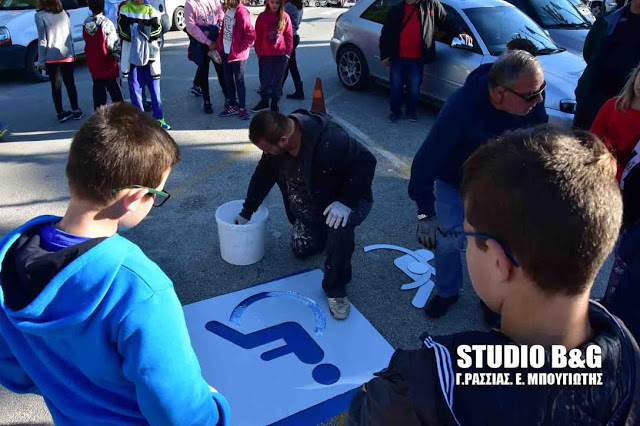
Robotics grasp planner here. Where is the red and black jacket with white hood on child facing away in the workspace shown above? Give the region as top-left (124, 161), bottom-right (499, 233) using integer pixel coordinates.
top-left (82, 14), bottom-right (120, 80)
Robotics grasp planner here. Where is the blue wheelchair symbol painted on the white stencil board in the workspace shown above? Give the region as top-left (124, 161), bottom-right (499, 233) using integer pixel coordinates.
top-left (205, 291), bottom-right (340, 385)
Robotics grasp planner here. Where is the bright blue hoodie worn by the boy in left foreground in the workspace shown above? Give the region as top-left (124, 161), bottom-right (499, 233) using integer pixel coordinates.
top-left (0, 216), bottom-right (229, 425)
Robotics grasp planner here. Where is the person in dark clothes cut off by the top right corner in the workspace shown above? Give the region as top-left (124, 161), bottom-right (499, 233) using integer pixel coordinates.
top-left (573, 0), bottom-right (640, 130)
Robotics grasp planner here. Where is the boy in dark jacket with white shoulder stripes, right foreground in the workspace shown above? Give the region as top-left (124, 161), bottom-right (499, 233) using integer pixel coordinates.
top-left (347, 126), bottom-right (640, 426)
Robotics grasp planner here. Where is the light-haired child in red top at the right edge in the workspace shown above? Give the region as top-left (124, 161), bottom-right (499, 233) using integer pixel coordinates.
top-left (591, 66), bottom-right (640, 181)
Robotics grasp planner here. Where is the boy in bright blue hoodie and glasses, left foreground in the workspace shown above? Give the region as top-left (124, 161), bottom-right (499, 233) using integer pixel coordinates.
top-left (0, 103), bottom-right (229, 425)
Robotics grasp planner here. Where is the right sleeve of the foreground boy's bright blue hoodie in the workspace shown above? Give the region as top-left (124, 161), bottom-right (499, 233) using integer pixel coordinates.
top-left (118, 287), bottom-right (230, 426)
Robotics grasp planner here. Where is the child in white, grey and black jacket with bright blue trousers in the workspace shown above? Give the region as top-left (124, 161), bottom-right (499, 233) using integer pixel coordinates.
top-left (118, 0), bottom-right (171, 130)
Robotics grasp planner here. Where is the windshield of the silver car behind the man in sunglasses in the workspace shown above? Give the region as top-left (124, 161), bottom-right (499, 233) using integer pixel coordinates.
top-left (464, 6), bottom-right (563, 56)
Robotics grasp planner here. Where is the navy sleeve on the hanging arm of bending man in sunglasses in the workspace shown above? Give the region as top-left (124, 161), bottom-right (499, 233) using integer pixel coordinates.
top-left (409, 100), bottom-right (464, 216)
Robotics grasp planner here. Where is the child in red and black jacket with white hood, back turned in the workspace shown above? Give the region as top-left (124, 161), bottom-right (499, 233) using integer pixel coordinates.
top-left (82, 0), bottom-right (123, 110)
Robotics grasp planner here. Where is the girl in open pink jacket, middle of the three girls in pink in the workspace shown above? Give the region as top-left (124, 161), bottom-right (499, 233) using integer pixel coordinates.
top-left (218, 0), bottom-right (256, 120)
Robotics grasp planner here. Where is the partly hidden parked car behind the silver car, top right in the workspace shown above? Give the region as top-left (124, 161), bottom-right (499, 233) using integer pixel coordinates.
top-left (506, 0), bottom-right (595, 55)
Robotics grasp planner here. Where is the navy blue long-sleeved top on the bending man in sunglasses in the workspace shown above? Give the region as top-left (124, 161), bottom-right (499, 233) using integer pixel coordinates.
top-left (409, 73), bottom-right (548, 216)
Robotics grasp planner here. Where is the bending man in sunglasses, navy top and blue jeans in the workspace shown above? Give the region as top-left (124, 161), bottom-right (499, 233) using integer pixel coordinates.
top-left (409, 50), bottom-right (546, 318)
